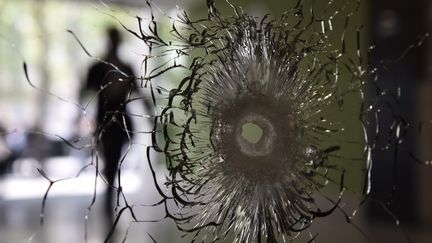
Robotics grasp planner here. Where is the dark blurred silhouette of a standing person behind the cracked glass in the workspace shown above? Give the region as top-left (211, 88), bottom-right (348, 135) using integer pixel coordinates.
top-left (81, 27), bottom-right (152, 233)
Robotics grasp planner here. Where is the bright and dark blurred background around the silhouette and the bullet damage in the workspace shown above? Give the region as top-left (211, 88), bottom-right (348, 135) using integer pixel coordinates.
top-left (0, 0), bottom-right (432, 243)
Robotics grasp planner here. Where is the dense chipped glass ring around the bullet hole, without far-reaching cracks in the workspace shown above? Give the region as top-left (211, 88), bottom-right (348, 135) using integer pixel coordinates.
top-left (143, 1), bottom-right (370, 242)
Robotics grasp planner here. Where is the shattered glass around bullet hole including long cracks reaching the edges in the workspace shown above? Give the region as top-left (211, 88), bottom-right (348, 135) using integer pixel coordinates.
top-left (1, 0), bottom-right (431, 242)
